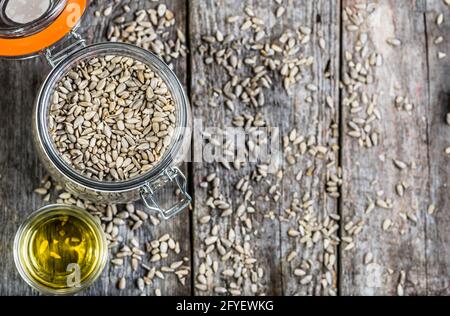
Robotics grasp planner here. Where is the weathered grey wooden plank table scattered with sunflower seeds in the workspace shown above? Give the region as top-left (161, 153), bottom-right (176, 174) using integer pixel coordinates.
top-left (0, 0), bottom-right (450, 295)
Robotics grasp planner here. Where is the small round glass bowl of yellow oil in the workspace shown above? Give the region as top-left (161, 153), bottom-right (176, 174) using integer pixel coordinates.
top-left (14, 205), bottom-right (108, 295)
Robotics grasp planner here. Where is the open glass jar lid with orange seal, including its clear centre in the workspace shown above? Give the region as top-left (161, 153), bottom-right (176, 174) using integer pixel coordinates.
top-left (0, 0), bottom-right (88, 58)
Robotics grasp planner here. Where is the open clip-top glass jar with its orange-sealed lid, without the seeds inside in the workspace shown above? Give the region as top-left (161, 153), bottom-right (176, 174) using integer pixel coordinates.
top-left (0, 0), bottom-right (192, 219)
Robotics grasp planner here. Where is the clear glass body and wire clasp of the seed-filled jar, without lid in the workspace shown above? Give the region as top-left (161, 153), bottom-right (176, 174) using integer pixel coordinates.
top-left (33, 43), bottom-right (192, 219)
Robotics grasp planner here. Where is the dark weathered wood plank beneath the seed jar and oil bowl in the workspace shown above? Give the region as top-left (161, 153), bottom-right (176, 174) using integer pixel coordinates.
top-left (0, 0), bottom-right (191, 295)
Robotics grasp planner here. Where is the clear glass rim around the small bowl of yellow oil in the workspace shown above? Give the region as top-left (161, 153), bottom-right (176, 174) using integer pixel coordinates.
top-left (13, 204), bottom-right (108, 295)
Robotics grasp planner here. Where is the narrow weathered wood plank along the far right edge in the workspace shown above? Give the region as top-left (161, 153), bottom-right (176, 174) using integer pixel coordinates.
top-left (426, 1), bottom-right (450, 295)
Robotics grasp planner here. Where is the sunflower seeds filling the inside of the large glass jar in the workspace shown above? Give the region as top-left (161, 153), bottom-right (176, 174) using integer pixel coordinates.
top-left (48, 55), bottom-right (176, 181)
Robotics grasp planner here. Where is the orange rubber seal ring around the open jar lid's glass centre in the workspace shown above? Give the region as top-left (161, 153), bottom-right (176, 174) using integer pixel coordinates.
top-left (0, 0), bottom-right (88, 57)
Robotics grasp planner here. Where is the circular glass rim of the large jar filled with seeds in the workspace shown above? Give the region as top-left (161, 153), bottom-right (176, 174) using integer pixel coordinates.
top-left (34, 42), bottom-right (190, 192)
